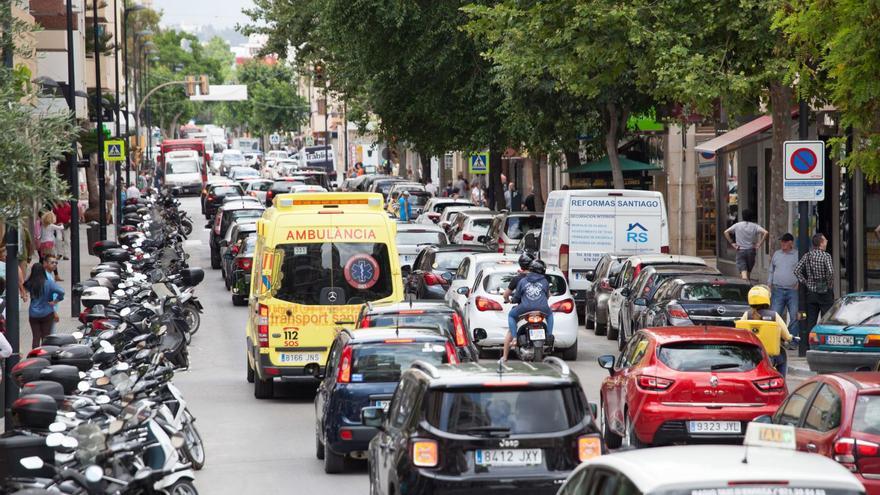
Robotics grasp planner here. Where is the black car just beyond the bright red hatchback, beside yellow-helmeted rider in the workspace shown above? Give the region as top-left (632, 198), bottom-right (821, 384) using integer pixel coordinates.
top-left (640, 275), bottom-right (752, 328)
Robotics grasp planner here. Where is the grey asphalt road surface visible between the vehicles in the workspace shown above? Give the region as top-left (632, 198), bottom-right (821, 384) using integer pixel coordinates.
top-left (175, 197), bottom-right (792, 495)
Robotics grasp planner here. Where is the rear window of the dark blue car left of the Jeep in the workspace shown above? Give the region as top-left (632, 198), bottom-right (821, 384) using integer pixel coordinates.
top-left (351, 339), bottom-right (446, 383)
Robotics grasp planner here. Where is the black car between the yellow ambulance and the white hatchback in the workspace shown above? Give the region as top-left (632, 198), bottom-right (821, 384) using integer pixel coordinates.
top-left (404, 244), bottom-right (489, 300)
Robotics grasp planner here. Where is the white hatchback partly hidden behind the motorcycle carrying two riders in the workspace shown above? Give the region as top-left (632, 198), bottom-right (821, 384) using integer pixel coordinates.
top-left (462, 263), bottom-right (578, 361)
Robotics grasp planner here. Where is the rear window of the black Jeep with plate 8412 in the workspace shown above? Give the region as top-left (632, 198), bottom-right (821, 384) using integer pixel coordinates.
top-left (429, 389), bottom-right (584, 436)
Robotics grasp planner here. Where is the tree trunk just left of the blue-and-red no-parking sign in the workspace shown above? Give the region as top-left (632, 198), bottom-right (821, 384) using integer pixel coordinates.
top-left (768, 81), bottom-right (793, 248)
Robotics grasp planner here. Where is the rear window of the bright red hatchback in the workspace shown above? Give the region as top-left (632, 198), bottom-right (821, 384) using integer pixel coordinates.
top-left (657, 342), bottom-right (764, 372)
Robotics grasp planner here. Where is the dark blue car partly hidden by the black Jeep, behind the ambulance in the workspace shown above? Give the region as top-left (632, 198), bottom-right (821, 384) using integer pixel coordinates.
top-left (315, 325), bottom-right (458, 474)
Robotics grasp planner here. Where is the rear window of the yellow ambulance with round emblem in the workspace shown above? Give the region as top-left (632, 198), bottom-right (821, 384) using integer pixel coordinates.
top-left (275, 242), bottom-right (394, 305)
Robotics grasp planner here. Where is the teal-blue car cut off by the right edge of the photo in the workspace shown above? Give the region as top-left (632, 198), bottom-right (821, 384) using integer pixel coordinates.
top-left (807, 292), bottom-right (880, 373)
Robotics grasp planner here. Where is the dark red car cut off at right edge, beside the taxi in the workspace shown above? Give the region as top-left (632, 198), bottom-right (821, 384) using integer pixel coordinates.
top-left (773, 372), bottom-right (880, 495)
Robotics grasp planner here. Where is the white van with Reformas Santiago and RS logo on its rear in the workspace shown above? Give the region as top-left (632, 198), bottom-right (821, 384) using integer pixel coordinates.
top-left (540, 189), bottom-right (669, 292)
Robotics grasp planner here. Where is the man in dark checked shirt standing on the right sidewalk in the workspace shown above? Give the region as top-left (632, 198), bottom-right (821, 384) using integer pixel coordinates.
top-left (794, 233), bottom-right (834, 342)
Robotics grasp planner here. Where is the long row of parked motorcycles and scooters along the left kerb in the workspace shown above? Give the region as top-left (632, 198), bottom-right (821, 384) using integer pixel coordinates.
top-left (0, 195), bottom-right (205, 495)
